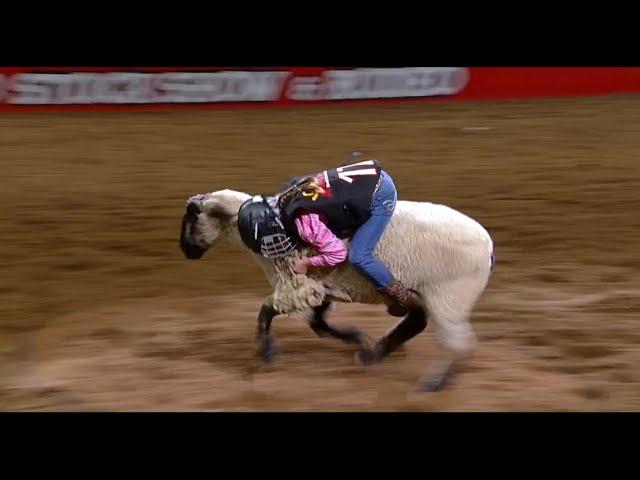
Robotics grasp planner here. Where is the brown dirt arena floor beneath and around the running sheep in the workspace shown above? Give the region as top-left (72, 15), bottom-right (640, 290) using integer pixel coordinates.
top-left (0, 96), bottom-right (640, 411)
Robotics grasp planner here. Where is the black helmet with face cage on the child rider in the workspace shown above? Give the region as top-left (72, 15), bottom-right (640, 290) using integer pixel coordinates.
top-left (238, 195), bottom-right (298, 258)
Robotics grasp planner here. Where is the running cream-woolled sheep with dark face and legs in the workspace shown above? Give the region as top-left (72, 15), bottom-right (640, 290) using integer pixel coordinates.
top-left (180, 189), bottom-right (494, 391)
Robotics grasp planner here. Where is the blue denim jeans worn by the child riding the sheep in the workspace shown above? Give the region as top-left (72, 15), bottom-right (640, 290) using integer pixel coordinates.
top-left (349, 171), bottom-right (398, 288)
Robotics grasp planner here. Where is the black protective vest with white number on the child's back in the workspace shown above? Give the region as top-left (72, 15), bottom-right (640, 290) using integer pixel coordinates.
top-left (280, 160), bottom-right (382, 238)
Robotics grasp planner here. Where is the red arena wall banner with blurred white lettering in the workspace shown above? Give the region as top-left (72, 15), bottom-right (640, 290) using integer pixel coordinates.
top-left (0, 67), bottom-right (640, 111)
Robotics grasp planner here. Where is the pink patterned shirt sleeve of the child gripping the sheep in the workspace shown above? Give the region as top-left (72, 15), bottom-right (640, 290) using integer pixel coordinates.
top-left (294, 212), bottom-right (347, 267)
